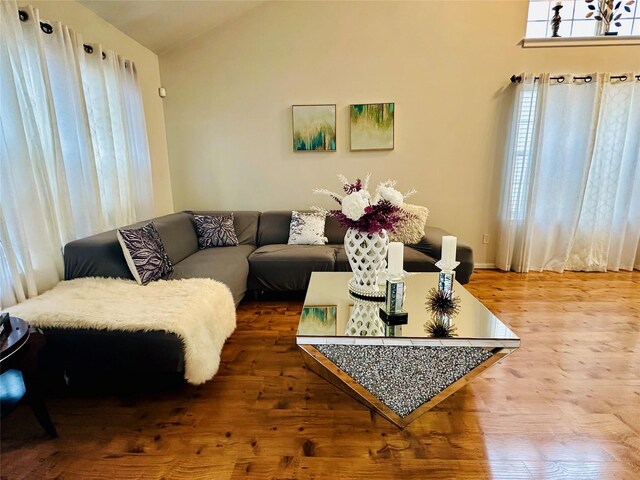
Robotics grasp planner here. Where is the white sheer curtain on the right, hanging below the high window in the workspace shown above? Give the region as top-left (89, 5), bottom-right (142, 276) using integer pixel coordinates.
top-left (496, 73), bottom-right (640, 272)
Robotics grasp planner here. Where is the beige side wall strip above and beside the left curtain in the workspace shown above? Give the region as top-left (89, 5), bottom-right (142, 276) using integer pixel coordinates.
top-left (30, 1), bottom-right (173, 215)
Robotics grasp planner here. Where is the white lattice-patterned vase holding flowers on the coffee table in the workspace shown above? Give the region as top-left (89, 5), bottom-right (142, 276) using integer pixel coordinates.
top-left (344, 228), bottom-right (389, 295)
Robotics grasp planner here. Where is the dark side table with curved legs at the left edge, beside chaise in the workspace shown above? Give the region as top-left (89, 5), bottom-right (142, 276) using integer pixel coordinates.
top-left (0, 317), bottom-right (58, 438)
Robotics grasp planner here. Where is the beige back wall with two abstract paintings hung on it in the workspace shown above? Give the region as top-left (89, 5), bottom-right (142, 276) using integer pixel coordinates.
top-left (160, 1), bottom-right (640, 263)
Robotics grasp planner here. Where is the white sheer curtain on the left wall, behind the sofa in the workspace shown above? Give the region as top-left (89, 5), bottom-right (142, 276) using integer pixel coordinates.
top-left (0, 1), bottom-right (153, 308)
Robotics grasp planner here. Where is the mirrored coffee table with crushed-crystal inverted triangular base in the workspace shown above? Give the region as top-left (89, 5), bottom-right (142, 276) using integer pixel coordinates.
top-left (296, 272), bottom-right (520, 427)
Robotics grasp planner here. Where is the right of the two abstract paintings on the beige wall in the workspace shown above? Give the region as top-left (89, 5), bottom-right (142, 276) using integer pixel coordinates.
top-left (350, 103), bottom-right (395, 151)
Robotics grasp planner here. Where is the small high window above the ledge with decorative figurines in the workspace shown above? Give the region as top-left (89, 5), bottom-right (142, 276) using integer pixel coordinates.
top-left (525, 0), bottom-right (640, 38)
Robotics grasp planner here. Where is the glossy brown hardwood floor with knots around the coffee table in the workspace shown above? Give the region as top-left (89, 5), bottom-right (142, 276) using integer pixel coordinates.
top-left (1, 270), bottom-right (640, 480)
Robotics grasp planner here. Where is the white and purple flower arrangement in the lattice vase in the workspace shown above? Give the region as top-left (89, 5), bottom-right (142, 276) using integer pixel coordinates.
top-left (312, 174), bottom-right (416, 234)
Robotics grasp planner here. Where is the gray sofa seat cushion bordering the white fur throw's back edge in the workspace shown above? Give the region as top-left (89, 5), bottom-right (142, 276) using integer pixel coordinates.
top-left (166, 245), bottom-right (256, 306)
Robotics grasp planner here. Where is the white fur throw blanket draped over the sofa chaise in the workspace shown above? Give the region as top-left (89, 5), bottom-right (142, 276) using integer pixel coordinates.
top-left (9, 278), bottom-right (236, 384)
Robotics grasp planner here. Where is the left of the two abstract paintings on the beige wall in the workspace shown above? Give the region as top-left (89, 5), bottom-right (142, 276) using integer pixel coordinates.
top-left (291, 105), bottom-right (336, 152)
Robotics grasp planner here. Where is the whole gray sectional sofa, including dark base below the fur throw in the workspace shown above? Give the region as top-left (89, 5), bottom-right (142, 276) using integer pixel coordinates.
top-left (44, 211), bottom-right (473, 382)
